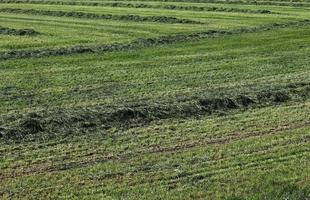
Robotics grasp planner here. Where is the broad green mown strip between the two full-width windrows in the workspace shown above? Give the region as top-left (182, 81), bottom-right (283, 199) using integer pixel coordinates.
top-left (0, 24), bottom-right (309, 113)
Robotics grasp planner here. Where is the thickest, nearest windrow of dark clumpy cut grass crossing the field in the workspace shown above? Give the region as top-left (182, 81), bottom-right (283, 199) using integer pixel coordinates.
top-left (0, 83), bottom-right (310, 142)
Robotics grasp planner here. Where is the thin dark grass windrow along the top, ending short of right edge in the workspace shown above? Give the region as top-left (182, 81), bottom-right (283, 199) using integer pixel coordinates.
top-left (1, 0), bottom-right (276, 14)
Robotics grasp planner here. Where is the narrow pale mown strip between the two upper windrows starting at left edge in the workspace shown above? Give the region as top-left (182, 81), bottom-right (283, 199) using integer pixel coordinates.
top-left (0, 3), bottom-right (302, 23)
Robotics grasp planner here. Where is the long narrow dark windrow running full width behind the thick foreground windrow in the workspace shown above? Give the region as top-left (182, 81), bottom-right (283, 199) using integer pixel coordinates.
top-left (0, 19), bottom-right (310, 60)
